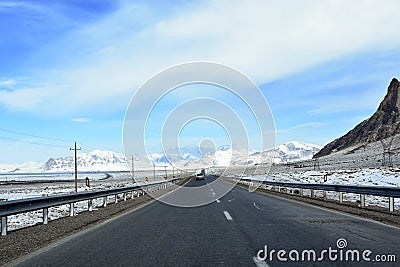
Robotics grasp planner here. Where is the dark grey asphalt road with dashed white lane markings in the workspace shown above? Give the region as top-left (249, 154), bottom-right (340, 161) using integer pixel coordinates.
top-left (14, 176), bottom-right (400, 266)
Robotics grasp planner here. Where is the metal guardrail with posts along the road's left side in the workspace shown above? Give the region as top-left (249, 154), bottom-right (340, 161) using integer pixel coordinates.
top-left (0, 178), bottom-right (180, 236)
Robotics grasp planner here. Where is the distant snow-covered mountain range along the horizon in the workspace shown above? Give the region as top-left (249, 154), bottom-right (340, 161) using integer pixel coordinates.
top-left (0, 142), bottom-right (321, 173)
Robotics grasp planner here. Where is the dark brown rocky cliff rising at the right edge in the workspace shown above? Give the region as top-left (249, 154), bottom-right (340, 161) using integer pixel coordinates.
top-left (314, 79), bottom-right (400, 158)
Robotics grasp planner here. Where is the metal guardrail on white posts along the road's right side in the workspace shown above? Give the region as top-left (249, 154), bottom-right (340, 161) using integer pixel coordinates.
top-left (235, 179), bottom-right (400, 215)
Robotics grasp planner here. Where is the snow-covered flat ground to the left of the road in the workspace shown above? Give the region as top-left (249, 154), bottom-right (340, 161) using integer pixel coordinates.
top-left (0, 171), bottom-right (173, 230)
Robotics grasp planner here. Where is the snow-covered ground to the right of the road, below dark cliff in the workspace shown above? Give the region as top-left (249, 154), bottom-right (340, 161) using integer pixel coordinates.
top-left (230, 168), bottom-right (400, 213)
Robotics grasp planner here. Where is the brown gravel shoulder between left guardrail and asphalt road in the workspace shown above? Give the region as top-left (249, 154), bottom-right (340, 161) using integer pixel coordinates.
top-left (0, 178), bottom-right (190, 266)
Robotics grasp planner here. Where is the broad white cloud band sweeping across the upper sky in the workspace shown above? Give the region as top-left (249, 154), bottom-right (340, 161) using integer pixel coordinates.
top-left (0, 1), bottom-right (400, 116)
